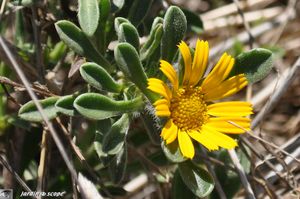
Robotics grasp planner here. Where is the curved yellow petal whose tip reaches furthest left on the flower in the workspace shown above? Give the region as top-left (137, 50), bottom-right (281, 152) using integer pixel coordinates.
top-left (147, 78), bottom-right (172, 101)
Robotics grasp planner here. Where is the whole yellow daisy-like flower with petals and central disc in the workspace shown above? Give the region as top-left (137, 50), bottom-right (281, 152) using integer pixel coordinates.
top-left (148, 40), bottom-right (252, 158)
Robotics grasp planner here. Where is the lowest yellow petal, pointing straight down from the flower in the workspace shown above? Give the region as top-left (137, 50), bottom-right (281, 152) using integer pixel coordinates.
top-left (178, 129), bottom-right (195, 159)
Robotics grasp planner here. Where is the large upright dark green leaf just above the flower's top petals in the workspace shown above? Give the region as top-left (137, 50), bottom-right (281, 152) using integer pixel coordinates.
top-left (161, 6), bottom-right (187, 62)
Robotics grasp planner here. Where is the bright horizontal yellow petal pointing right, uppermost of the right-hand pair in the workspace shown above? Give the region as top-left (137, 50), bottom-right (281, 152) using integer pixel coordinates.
top-left (207, 101), bottom-right (253, 117)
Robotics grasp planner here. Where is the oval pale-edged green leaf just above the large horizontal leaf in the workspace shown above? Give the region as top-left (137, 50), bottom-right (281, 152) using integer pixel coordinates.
top-left (80, 62), bottom-right (122, 93)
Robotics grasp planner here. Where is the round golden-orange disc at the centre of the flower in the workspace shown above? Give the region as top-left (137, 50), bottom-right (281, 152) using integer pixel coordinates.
top-left (170, 87), bottom-right (208, 131)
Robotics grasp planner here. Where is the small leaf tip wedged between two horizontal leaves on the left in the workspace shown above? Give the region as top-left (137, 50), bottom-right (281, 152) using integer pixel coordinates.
top-left (55, 95), bottom-right (76, 117)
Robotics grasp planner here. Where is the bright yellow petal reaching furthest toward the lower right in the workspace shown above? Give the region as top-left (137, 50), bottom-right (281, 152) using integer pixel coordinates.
top-left (202, 125), bottom-right (237, 149)
